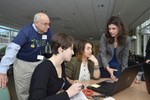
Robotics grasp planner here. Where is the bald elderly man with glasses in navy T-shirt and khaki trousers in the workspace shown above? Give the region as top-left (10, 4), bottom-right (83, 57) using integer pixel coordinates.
top-left (0, 12), bottom-right (52, 100)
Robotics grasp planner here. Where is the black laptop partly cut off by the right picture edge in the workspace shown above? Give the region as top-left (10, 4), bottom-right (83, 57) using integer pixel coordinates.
top-left (143, 63), bottom-right (150, 94)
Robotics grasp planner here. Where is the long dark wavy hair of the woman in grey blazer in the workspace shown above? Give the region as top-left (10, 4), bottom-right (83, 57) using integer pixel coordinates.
top-left (105, 16), bottom-right (128, 45)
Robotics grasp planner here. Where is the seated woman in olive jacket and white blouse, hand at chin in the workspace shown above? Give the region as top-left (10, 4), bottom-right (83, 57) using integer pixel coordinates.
top-left (66, 39), bottom-right (100, 83)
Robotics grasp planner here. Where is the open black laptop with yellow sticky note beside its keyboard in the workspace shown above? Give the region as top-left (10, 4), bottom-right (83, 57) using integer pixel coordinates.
top-left (87, 64), bottom-right (142, 96)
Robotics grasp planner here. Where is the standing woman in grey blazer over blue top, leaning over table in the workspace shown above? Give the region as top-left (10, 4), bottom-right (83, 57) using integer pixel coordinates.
top-left (100, 16), bottom-right (130, 80)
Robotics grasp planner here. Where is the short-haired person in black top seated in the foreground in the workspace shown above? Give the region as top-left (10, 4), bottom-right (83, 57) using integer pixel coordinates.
top-left (28, 33), bottom-right (82, 100)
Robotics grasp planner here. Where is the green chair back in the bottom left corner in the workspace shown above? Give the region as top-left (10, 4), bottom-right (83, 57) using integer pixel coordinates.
top-left (0, 87), bottom-right (11, 100)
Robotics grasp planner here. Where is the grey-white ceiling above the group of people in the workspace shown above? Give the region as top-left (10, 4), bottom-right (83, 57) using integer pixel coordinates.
top-left (0, 0), bottom-right (150, 40)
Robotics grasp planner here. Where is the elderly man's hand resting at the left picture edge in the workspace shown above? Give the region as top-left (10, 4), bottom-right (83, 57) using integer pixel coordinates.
top-left (0, 73), bottom-right (8, 89)
